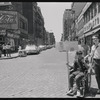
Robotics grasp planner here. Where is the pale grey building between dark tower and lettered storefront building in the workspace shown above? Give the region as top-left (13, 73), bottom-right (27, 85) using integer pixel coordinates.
top-left (71, 2), bottom-right (86, 40)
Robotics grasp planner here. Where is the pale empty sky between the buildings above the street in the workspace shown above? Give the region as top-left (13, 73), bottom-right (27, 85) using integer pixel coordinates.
top-left (37, 2), bottom-right (72, 42)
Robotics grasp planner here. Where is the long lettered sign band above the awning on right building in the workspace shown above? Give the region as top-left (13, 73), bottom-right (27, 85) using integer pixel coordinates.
top-left (84, 14), bottom-right (100, 33)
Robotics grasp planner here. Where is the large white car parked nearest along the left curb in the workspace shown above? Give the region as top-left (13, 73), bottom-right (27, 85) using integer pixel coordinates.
top-left (25, 45), bottom-right (40, 54)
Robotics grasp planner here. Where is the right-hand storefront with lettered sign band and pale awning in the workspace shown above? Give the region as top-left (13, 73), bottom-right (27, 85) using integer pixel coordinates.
top-left (84, 13), bottom-right (100, 46)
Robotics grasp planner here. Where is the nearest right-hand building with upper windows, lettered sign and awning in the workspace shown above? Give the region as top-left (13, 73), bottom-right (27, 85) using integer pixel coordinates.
top-left (77, 2), bottom-right (100, 46)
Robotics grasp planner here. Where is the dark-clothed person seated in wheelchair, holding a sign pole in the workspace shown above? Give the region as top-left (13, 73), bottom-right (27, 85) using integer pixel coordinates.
top-left (67, 51), bottom-right (87, 96)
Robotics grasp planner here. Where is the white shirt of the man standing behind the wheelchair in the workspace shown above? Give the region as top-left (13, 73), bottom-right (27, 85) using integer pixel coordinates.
top-left (91, 43), bottom-right (100, 59)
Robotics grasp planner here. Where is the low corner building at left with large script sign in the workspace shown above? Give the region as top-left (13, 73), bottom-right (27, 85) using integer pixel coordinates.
top-left (0, 10), bottom-right (28, 50)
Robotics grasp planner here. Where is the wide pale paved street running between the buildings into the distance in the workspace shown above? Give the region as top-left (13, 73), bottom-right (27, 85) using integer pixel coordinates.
top-left (0, 48), bottom-right (99, 98)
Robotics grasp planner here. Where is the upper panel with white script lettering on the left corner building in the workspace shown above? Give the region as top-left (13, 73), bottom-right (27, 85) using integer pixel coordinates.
top-left (0, 13), bottom-right (16, 24)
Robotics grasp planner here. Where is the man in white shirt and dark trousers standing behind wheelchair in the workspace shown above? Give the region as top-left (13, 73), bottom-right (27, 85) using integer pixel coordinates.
top-left (85, 35), bottom-right (100, 94)
